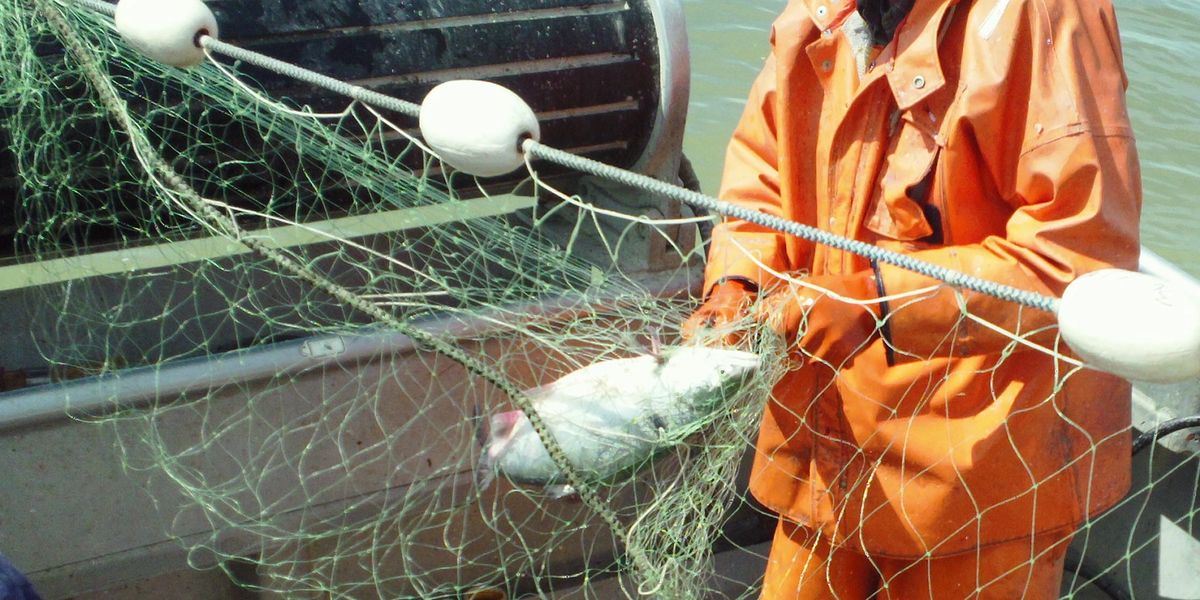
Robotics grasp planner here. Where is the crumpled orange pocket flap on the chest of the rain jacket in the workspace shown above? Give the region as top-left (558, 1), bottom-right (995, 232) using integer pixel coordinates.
top-left (864, 115), bottom-right (943, 244)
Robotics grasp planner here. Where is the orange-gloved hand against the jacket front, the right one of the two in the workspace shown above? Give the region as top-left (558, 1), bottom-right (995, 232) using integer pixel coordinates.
top-left (755, 272), bottom-right (880, 367)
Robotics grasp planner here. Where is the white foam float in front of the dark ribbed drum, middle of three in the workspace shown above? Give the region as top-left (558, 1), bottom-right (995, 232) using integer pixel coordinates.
top-left (420, 80), bottom-right (541, 178)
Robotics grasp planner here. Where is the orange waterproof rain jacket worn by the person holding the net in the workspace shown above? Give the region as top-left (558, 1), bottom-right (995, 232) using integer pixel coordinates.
top-left (706, 0), bottom-right (1141, 558)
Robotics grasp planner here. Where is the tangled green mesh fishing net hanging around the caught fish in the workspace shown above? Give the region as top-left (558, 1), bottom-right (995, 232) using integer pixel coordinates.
top-left (0, 0), bottom-right (1196, 598)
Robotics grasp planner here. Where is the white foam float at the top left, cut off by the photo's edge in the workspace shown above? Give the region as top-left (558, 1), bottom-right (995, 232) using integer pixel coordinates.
top-left (115, 0), bottom-right (217, 67)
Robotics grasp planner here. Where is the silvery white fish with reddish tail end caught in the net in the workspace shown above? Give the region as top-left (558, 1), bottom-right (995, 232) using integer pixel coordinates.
top-left (478, 347), bottom-right (760, 497)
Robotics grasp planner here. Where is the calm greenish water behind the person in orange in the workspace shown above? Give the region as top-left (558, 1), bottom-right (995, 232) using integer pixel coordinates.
top-left (684, 0), bottom-right (1200, 276)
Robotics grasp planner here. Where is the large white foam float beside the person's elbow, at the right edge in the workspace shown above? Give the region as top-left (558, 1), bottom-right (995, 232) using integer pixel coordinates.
top-left (1058, 269), bottom-right (1200, 383)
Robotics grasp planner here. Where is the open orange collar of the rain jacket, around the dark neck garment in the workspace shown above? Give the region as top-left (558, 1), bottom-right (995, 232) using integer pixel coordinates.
top-left (800, 0), bottom-right (959, 110)
